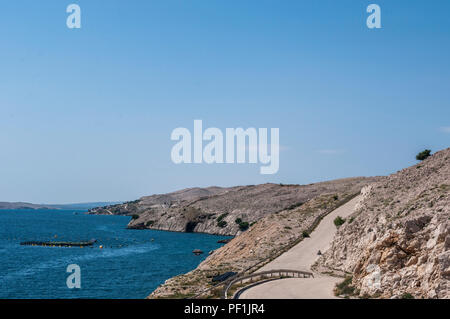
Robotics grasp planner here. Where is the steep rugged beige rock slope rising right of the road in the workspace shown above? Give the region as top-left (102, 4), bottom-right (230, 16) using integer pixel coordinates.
top-left (316, 149), bottom-right (450, 298)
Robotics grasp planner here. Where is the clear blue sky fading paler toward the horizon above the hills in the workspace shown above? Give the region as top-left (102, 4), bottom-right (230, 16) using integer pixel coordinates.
top-left (0, 0), bottom-right (450, 203)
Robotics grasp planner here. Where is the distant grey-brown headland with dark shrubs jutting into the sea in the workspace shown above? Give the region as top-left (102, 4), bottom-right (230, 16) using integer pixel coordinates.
top-left (89, 178), bottom-right (373, 235)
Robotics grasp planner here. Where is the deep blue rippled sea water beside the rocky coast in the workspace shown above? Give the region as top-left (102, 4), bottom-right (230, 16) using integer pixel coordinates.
top-left (0, 210), bottom-right (227, 299)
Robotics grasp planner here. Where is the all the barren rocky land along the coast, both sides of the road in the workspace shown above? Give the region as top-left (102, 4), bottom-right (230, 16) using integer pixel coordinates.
top-left (90, 149), bottom-right (450, 298)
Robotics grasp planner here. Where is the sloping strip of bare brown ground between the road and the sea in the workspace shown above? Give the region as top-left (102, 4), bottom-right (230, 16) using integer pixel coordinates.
top-left (149, 178), bottom-right (377, 298)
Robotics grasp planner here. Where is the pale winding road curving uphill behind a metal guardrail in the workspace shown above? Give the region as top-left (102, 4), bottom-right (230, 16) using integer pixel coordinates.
top-left (240, 196), bottom-right (361, 299)
